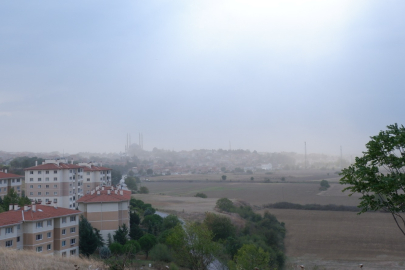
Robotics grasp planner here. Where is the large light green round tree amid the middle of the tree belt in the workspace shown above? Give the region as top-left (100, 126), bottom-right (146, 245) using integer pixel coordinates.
top-left (166, 223), bottom-right (219, 270)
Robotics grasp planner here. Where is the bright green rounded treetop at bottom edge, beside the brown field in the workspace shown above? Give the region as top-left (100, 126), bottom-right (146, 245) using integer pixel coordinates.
top-left (229, 244), bottom-right (270, 270)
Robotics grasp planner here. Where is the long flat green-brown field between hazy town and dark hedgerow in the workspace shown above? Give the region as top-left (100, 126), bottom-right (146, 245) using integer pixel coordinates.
top-left (142, 181), bottom-right (358, 206)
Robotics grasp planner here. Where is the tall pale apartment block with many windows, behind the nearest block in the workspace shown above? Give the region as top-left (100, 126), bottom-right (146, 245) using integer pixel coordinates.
top-left (25, 159), bottom-right (83, 209)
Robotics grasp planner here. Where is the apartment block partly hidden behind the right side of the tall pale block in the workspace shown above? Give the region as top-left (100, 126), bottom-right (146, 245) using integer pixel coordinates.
top-left (78, 163), bottom-right (111, 194)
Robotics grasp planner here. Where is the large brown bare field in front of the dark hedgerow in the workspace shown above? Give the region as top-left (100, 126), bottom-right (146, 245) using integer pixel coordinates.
top-left (258, 209), bottom-right (405, 269)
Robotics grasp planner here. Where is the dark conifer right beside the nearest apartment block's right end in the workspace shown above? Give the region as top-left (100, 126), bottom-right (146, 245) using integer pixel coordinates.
top-left (79, 216), bottom-right (99, 257)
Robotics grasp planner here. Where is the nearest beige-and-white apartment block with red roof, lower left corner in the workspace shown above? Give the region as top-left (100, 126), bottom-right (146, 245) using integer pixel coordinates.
top-left (0, 204), bottom-right (81, 257)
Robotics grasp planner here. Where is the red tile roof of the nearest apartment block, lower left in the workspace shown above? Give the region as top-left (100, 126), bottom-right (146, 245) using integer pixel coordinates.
top-left (0, 204), bottom-right (82, 227)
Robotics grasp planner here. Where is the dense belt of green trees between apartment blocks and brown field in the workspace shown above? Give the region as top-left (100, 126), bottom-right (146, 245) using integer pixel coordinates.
top-left (79, 198), bottom-right (285, 270)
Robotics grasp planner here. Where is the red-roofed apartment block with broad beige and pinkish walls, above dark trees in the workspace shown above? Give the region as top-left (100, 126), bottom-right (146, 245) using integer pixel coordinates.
top-left (77, 186), bottom-right (131, 240)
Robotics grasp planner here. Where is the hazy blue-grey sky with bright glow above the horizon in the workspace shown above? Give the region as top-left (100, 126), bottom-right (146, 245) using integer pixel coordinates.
top-left (0, 0), bottom-right (405, 154)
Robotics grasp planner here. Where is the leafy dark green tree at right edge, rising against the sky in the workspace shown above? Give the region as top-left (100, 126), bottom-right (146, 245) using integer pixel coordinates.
top-left (340, 124), bottom-right (405, 235)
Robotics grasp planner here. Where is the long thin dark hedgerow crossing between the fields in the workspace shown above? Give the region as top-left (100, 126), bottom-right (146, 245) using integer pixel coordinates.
top-left (263, 202), bottom-right (360, 212)
